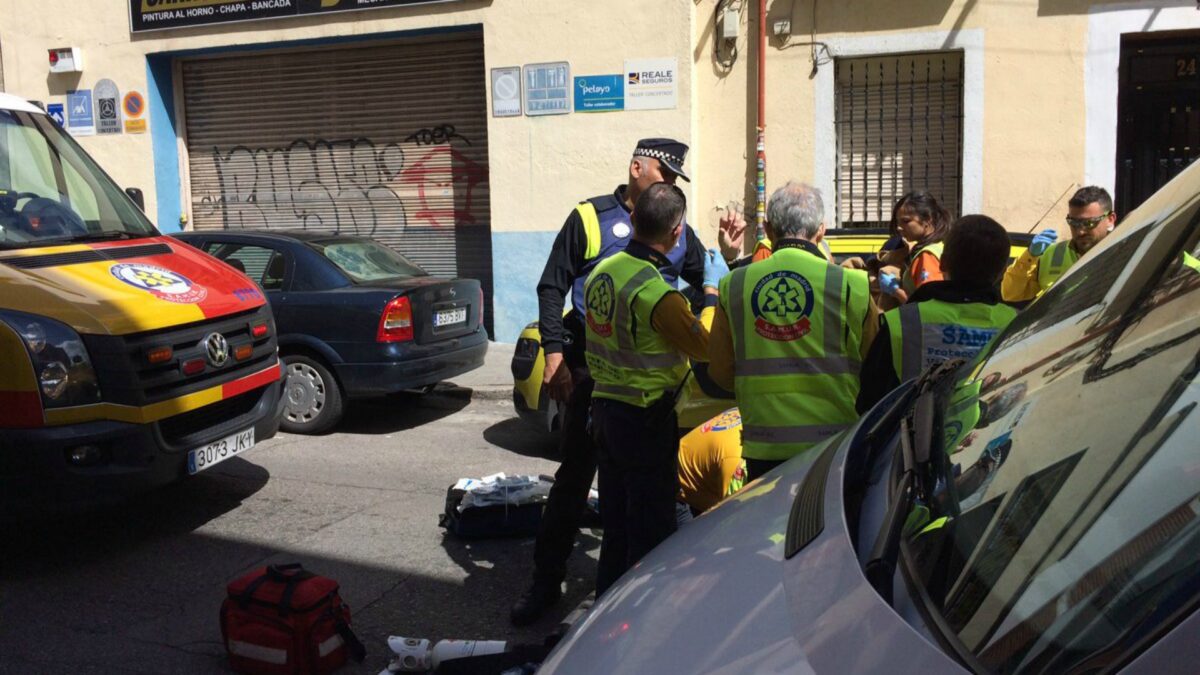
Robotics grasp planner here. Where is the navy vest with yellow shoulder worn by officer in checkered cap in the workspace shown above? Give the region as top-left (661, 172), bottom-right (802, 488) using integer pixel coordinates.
top-left (571, 193), bottom-right (689, 315)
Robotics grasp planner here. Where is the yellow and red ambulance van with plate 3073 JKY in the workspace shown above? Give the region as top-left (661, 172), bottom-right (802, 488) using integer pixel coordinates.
top-left (0, 94), bottom-right (282, 502)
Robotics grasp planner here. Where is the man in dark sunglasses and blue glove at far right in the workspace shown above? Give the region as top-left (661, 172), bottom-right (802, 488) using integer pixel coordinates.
top-left (1001, 185), bottom-right (1117, 303)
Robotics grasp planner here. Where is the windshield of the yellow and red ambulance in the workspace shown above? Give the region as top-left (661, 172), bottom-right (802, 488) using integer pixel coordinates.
top-left (0, 109), bottom-right (158, 250)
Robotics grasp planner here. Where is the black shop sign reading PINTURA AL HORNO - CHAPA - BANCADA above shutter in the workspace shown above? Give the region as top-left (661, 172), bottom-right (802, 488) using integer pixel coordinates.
top-left (130, 0), bottom-right (460, 32)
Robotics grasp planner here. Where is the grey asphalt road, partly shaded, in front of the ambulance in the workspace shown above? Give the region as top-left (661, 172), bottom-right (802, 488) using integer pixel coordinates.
top-left (0, 386), bottom-right (600, 674)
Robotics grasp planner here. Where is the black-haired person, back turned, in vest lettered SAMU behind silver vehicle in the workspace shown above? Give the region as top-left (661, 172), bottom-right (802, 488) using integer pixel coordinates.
top-left (856, 215), bottom-right (1016, 413)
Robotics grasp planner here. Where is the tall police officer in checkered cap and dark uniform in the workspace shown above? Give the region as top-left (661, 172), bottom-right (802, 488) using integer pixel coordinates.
top-left (510, 138), bottom-right (706, 626)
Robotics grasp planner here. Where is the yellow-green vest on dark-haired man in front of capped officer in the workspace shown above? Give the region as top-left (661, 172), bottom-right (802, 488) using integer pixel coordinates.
top-left (583, 251), bottom-right (688, 407)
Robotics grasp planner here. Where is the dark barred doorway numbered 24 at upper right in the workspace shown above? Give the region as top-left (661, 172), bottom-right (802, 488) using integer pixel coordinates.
top-left (1113, 30), bottom-right (1200, 215)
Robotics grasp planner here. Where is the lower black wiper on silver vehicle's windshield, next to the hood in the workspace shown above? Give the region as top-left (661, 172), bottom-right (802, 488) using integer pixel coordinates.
top-left (863, 360), bottom-right (962, 604)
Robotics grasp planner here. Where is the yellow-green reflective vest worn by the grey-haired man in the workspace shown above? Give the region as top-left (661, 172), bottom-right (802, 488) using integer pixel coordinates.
top-left (720, 247), bottom-right (870, 460)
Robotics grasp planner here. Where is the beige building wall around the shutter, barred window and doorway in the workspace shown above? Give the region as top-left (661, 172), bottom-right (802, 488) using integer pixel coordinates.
top-left (0, 0), bottom-right (1200, 241)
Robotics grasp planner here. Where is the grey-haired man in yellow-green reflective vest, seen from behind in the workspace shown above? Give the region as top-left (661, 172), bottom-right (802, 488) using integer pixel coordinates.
top-left (708, 183), bottom-right (877, 480)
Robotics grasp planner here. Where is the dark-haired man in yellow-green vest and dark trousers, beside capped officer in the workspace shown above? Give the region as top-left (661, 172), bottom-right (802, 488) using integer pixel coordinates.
top-left (583, 183), bottom-right (728, 597)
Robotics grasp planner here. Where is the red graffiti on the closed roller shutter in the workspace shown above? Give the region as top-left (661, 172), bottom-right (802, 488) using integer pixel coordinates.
top-left (401, 145), bottom-right (487, 227)
